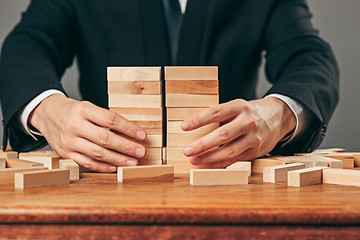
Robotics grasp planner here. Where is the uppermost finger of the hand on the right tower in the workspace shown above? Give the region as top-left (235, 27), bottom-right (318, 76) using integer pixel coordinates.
top-left (181, 99), bottom-right (245, 131)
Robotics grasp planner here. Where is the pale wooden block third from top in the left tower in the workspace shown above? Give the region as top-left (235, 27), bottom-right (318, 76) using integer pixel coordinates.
top-left (109, 94), bottom-right (162, 108)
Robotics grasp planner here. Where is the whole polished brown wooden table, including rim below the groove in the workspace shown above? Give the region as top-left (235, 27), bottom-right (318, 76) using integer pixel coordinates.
top-left (0, 173), bottom-right (360, 239)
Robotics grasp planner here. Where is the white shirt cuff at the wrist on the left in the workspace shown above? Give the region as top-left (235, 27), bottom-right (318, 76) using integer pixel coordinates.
top-left (18, 89), bottom-right (65, 140)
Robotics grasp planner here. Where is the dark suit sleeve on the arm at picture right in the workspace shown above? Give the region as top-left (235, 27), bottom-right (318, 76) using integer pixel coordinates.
top-left (265, 0), bottom-right (339, 155)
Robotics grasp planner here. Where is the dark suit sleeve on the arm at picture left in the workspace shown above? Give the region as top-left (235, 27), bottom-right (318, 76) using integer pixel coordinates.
top-left (0, 0), bottom-right (76, 151)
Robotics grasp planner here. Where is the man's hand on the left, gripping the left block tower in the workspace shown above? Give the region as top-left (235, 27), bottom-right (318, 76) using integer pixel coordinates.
top-left (29, 94), bottom-right (146, 172)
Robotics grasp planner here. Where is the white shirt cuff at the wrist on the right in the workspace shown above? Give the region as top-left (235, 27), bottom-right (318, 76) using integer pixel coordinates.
top-left (266, 94), bottom-right (312, 145)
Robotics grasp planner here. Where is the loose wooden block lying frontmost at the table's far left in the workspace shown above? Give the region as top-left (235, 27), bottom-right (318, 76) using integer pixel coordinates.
top-left (15, 169), bottom-right (70, 189)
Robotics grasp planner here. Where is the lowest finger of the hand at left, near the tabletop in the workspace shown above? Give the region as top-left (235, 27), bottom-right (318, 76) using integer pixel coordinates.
top-left (70, 152), bottom-right (116, 173)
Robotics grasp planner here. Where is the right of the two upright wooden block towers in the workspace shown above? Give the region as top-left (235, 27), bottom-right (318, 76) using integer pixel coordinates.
top-left (165, 67), bottom-right (219, 173)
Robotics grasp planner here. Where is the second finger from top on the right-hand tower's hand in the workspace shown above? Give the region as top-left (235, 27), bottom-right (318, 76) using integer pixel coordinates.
top-left (184, 115), bottom-right (254, 157)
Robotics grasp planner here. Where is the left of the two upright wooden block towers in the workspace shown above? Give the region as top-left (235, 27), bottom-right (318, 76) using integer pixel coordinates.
top-left (107, 67), bottom-right (163, 165)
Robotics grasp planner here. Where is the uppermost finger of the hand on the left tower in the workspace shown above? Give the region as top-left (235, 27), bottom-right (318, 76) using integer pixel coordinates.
top-left (80, 102), bottom-right (146, 141)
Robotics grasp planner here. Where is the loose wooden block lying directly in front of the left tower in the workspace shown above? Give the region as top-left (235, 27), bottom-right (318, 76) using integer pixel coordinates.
top-left (118, 165), bottom-right (174, 183)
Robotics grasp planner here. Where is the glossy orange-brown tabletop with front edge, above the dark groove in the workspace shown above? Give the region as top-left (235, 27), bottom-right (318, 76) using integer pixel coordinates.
top-left (0, 173), bottom-right (360, 226)
